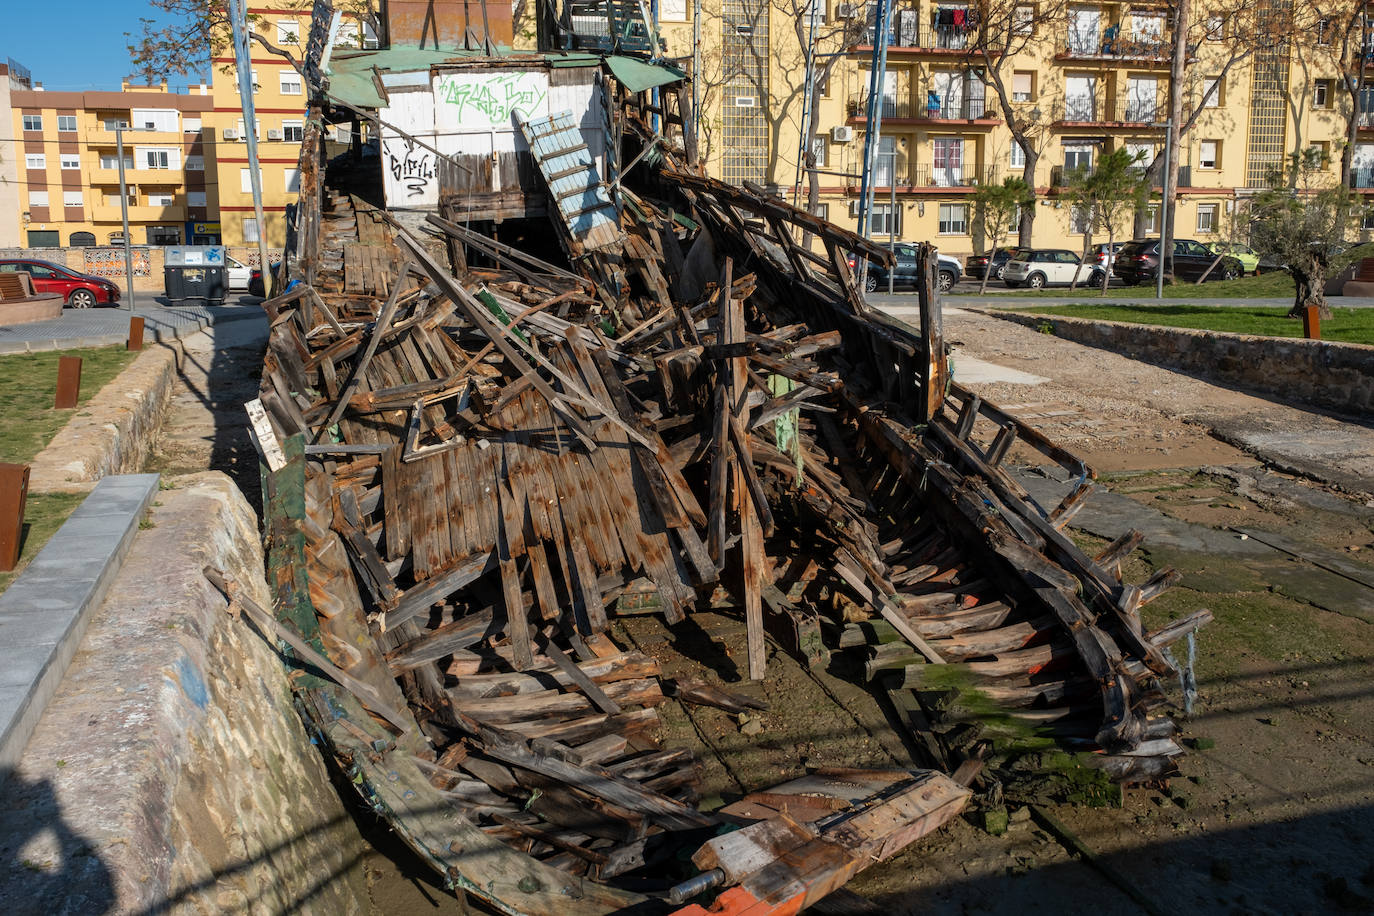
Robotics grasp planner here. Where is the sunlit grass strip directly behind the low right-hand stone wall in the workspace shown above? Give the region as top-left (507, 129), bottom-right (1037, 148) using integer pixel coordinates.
top-left (1015, 305), bottom-right (1374, 345)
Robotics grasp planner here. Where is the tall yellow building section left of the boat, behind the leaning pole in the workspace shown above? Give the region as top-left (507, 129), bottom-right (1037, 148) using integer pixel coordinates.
top-left (206, 0), bottom-right (376, 249)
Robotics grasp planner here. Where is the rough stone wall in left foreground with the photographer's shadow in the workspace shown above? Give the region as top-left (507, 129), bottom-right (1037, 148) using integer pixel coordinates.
top-left (0, 472), bottom-right (368, 916)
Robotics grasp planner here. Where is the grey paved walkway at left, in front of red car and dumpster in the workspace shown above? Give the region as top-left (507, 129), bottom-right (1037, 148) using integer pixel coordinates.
top-left (0, 300), bottom-right (262, 356)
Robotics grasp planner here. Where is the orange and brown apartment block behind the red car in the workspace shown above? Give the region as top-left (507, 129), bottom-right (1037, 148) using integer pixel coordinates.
top-left (8, 76), bottom-right (213, 247)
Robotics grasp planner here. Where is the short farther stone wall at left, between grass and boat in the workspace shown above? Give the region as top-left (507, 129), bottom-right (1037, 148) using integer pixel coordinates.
top-left (29, 341), bottom-right (185, 493)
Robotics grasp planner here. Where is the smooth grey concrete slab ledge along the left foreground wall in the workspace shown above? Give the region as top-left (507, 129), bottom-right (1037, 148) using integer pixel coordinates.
top-left (0, 474), bottom-right (159, 777)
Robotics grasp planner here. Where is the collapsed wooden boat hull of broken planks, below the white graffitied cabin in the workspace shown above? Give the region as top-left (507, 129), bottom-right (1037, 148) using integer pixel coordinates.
top-left (241, 60), bottom-right (1206, 915)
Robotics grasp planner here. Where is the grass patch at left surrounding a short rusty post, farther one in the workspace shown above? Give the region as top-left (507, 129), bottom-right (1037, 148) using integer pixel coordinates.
top-left (0, 346), bottom-right (137, 464)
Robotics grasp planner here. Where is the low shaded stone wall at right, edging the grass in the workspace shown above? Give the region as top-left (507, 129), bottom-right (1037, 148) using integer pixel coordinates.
top-left (976, 309), bottom-right (1374, 416)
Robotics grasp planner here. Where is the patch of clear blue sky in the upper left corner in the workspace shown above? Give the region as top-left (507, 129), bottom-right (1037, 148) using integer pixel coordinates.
top-left (9, 0), bottom-right (207, 92)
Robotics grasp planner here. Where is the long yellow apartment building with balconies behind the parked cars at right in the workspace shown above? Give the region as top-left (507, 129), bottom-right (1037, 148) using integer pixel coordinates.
top-left (517, 0), bottom-right (1374, 255)
